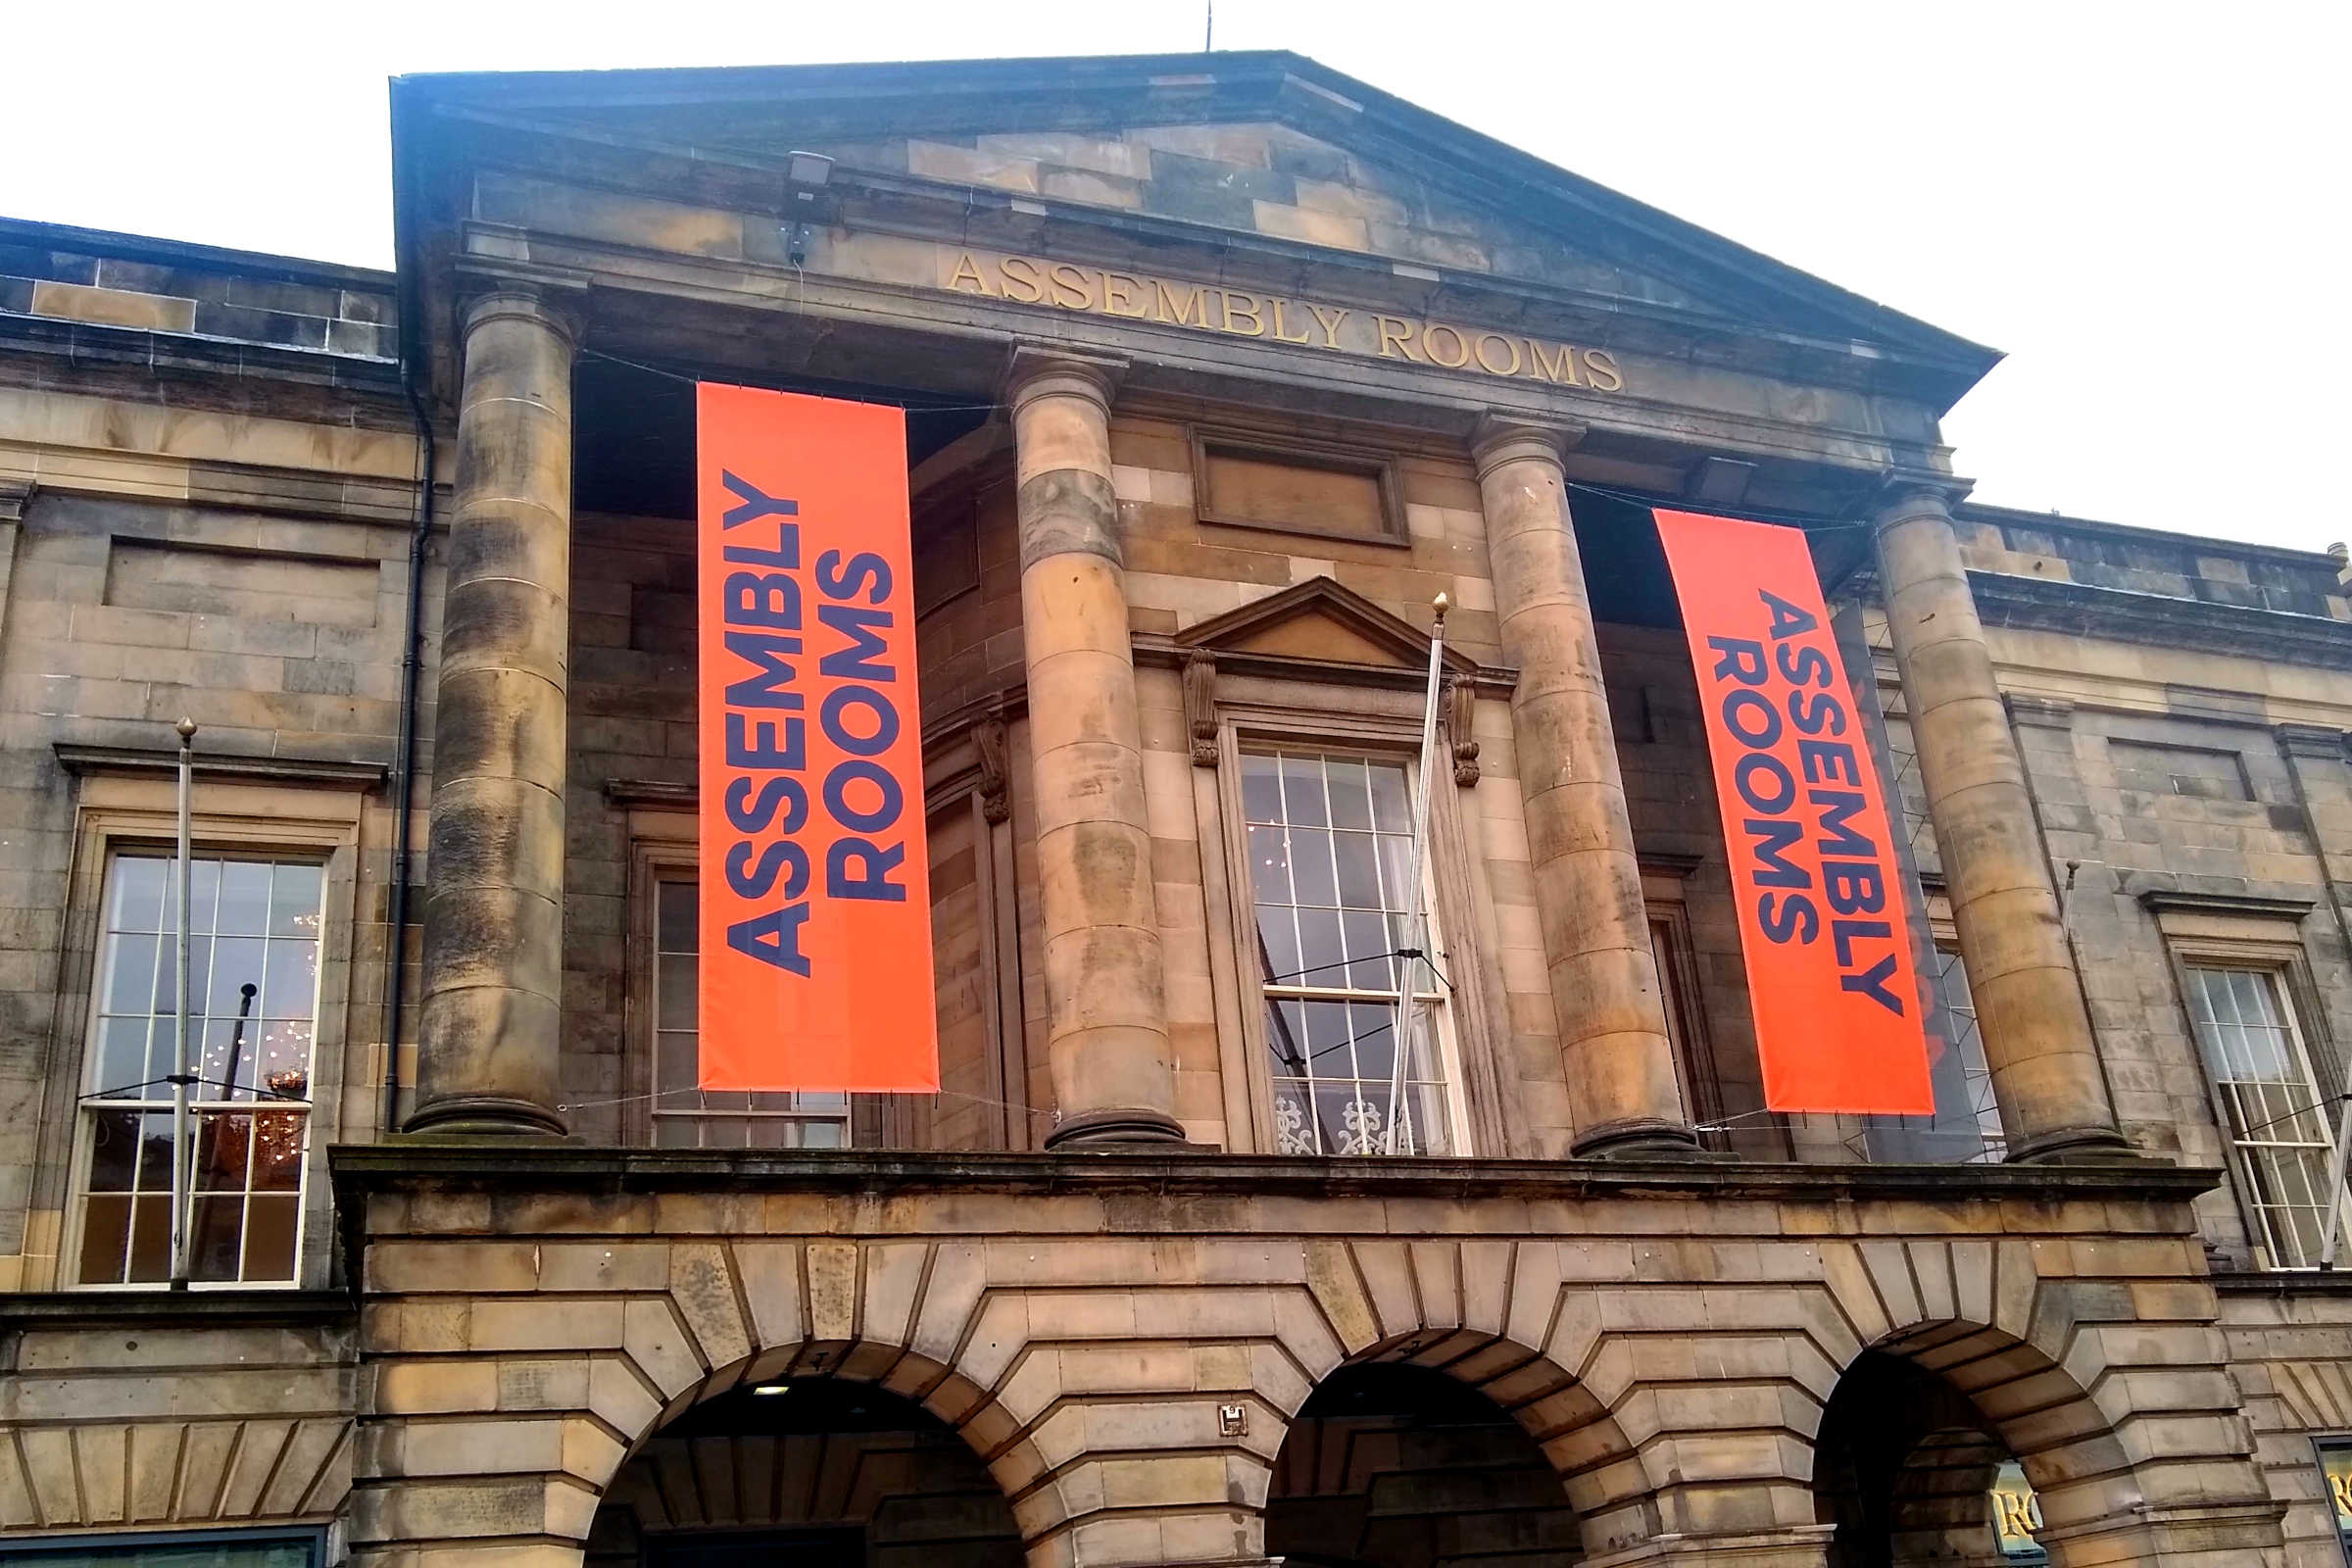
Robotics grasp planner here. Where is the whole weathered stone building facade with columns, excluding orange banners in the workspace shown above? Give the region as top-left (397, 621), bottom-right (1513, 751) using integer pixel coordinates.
top-left (0, 54), bottom-right (2352, 1568)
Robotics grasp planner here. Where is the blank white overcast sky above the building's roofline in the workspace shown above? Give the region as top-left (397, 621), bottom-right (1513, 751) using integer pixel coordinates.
top-left (0, 0), bottom-right (2352, 550)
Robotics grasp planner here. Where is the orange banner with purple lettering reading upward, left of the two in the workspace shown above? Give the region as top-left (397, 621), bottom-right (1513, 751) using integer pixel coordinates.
top-left (696, 383), bottom-right (939, 1091)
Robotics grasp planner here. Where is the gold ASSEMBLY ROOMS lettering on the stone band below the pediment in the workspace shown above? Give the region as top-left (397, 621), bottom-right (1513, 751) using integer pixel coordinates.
top-left (941, 249), bottom-right (1625, 393)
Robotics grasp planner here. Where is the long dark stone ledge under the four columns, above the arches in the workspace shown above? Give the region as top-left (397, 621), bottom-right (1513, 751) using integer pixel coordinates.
top-left (327, 1138), bottom-right (2221, 1203)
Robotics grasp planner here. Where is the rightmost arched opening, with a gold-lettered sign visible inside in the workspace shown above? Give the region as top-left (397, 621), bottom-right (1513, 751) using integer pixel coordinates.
top-left (1813, 1349), bottom-right (2048, 1568)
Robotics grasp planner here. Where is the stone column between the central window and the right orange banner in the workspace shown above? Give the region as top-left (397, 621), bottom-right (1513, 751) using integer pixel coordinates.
top-left (1475, 420), bottom-right (1698, 1154)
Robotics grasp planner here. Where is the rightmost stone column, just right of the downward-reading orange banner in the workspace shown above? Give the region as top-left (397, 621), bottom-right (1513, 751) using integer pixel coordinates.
top-left (1877, 484), bottom-right (2127, 1161)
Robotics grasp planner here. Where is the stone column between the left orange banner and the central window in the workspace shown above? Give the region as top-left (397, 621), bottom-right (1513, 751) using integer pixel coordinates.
top-left (1009, 348), bottom-right (1183, 1148)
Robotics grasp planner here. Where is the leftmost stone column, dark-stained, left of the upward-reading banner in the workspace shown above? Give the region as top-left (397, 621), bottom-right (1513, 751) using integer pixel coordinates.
top-left (407, 291), bottom-right (574, 1133)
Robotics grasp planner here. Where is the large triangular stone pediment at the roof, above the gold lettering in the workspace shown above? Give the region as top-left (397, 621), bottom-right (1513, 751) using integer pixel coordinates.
top-left (395, 52), bottom-right (1997, 385)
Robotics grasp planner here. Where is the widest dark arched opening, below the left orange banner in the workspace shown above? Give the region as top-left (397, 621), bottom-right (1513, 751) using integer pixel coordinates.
top-left (586, 1378), bottom-right (1023, 1568)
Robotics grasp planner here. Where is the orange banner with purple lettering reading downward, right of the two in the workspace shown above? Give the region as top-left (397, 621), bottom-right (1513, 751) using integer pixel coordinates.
top-left (1658, 513), bottom-right (1936, 1116)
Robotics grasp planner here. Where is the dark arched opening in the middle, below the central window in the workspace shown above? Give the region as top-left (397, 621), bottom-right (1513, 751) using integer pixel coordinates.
top-left (1265, 1361), bottom-right (1583, 1568)
